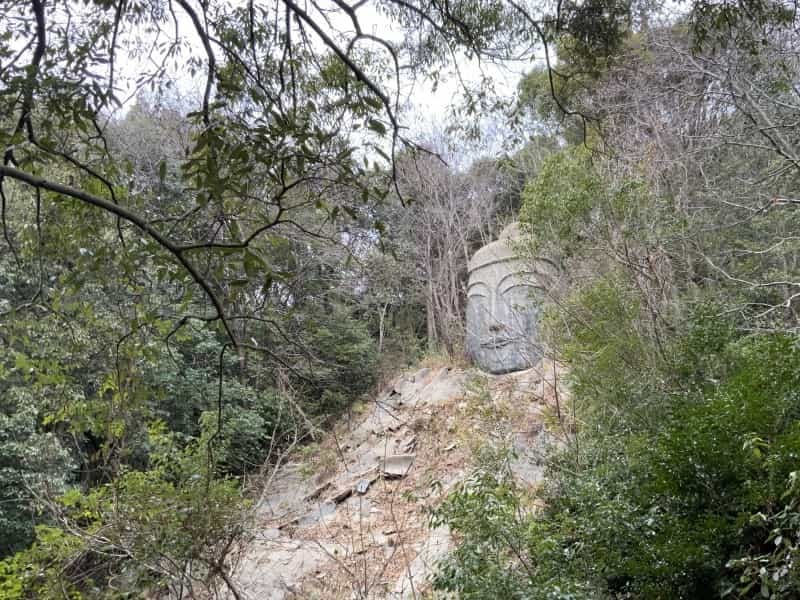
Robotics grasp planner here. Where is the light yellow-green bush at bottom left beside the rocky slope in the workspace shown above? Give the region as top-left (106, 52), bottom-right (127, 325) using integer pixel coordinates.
top-left (0, 424), bottom-right (249, 599)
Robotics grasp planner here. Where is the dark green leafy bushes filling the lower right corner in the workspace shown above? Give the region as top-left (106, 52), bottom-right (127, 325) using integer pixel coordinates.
top-left (436, 322), bottom-right (800, 600)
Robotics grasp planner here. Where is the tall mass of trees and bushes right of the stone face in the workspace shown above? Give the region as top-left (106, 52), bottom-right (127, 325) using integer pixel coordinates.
top-left (433, 3), bottom-right (800, 599)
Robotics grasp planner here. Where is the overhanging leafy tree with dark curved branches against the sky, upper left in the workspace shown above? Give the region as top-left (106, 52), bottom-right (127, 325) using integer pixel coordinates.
top-left (0, 0), bottom-right (648, 347)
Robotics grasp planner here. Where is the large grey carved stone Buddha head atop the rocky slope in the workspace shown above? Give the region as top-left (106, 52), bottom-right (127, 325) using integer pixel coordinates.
top-left (466, 223), bottom-right (554, 374)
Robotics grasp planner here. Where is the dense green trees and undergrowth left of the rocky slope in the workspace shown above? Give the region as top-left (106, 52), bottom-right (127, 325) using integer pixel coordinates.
top-left (0, 99), bottom-right (384, 598)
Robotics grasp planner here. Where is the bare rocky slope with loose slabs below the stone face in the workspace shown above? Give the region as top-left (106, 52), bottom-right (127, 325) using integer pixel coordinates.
top-left (227, 361), bottom-right (563, 600)
